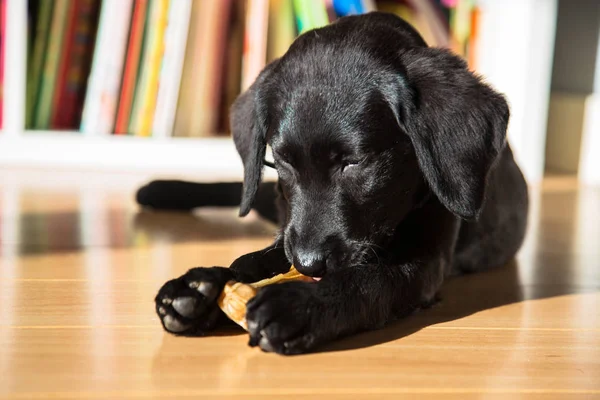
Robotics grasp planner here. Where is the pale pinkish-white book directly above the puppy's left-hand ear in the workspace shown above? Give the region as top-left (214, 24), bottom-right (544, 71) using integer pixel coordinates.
top-left (242, 0), bottom-right (269, 91)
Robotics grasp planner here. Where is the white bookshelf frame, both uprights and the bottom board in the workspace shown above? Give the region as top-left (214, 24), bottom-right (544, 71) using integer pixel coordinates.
top-left (0, 0), bottom-right (557, 182)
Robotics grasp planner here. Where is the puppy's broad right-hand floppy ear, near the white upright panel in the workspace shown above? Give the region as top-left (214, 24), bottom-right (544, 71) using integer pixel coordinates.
top-left (398, 48), bottom-right (509, 219)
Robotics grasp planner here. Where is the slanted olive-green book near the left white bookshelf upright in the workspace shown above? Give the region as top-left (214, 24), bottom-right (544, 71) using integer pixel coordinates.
top-left (25, 0), bottom-right (54, 129)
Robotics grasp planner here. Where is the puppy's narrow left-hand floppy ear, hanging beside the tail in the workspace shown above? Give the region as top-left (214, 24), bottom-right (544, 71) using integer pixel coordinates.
top-left (230, 61), bottom-right (276, 217)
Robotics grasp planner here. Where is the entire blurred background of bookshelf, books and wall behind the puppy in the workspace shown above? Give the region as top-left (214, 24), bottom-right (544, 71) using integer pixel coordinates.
top-left (0, 0), bottom-right (600, 184)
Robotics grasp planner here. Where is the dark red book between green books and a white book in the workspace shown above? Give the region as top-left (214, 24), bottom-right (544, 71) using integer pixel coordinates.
top-left (50, 0), bottom-right (100, 129)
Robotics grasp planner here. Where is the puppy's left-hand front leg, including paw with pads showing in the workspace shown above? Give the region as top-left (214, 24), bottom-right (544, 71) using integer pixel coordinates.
top-left (155, 242), bottom-right (290, 336)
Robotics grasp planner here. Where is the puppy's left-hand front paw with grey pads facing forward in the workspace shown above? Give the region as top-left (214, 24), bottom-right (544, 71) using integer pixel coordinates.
top-left (154, 267), bottom-right (231, 336)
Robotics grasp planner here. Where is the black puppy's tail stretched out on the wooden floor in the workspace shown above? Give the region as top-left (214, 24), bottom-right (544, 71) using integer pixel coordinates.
top-left (135, 180), bottom-right (277, 222)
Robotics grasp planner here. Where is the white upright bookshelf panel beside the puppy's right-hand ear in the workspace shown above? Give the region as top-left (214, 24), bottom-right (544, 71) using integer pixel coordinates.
top-left (476, 0), bottom-right (558, 183)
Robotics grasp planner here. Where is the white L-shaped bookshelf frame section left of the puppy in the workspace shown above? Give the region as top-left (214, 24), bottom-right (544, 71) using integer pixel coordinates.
top-left (0, 0), bottom-right (248, 179)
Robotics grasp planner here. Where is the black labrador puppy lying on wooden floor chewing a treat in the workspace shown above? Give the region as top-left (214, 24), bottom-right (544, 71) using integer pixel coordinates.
top-left (148, 13), bottom-right (528, 354)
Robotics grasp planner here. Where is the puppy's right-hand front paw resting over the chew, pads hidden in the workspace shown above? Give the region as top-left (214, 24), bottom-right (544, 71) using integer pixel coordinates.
top-left (246, 282), bottom-right (326, 354)
